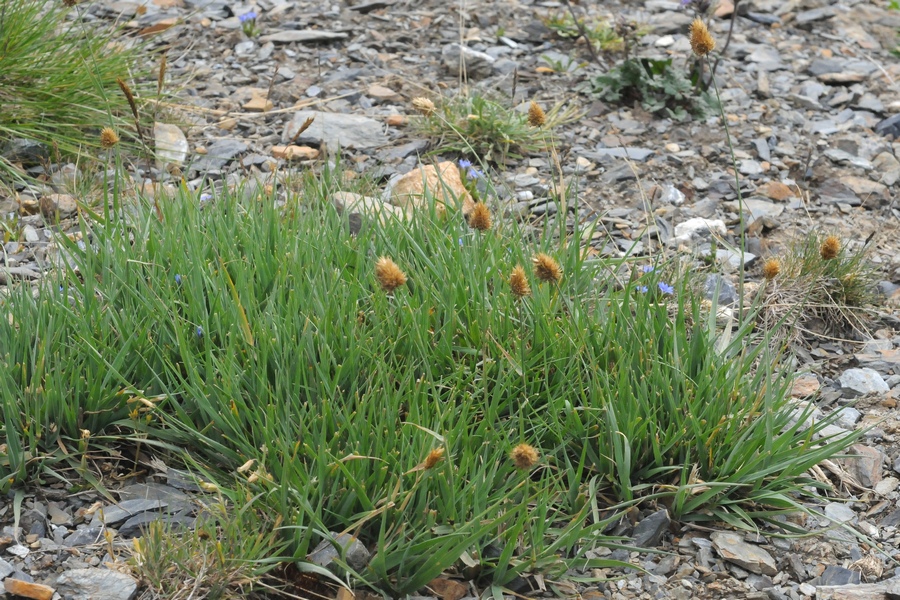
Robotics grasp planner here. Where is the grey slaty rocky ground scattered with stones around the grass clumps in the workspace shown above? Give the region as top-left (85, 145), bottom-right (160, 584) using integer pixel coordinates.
top-left (0, 0), bottom-right (900, 600)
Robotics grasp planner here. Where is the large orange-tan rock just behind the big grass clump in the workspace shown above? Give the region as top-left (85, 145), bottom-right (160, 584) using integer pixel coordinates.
top-left (391, 161), bottom-right (475, 215)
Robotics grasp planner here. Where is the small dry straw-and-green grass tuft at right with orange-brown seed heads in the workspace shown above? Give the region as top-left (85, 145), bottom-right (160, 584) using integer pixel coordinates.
top-left (763, 232), bottom-right (877, 339)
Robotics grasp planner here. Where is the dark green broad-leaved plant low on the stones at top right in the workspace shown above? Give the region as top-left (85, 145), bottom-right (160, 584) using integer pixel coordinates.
top-left (587, 58), bottom-right (715, 121)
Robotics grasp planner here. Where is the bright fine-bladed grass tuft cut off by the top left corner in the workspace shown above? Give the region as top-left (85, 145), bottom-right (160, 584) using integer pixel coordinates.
top-left (0, 0), bottom-right (150, 182)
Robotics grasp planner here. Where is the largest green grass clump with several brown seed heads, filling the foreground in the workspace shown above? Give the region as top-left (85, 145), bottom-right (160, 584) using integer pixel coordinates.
top-left (0, 163), bottom-right (861, 596)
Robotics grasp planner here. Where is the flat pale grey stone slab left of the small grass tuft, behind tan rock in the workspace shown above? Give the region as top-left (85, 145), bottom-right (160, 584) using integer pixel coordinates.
top-left (282, 110), bottom-right (388, 150)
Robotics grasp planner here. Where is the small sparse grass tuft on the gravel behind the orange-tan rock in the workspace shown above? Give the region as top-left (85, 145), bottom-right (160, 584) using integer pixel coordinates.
top-left (414, 92), bottom-right (576, 163)
